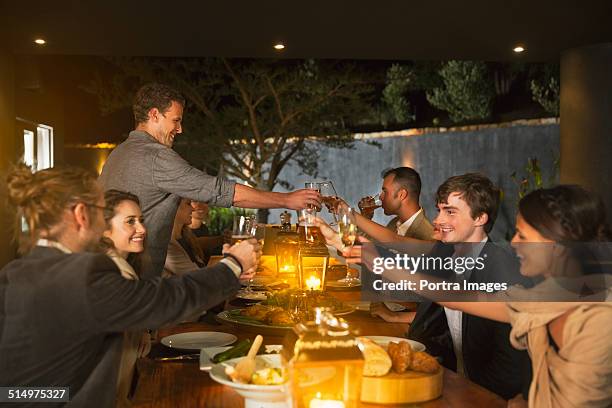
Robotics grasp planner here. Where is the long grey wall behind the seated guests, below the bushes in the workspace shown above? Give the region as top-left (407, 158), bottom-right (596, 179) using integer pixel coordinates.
top-left (269, 124), bottom-right (559, 238)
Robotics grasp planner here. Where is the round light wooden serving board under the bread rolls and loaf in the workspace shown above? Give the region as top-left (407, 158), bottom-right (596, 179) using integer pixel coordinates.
top-left (361, 368), bottom-right (444, 404)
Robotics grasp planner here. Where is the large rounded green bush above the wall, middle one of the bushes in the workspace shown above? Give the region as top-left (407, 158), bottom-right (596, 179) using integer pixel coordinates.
top-left (427, 61), bottom-right (495, 122)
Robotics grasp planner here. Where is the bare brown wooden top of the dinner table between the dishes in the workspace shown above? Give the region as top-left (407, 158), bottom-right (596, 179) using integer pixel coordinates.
top-left (132, 257), bottom-right (507, 408)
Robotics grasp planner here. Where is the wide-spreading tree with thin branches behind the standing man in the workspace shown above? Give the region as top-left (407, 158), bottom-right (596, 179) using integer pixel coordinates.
top-left (87, 58), bottom-right (376, 221)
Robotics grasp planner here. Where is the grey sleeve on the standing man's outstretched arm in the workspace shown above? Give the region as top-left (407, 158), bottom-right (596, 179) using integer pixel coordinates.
top-left (152, 149), bottom-right (236, 207)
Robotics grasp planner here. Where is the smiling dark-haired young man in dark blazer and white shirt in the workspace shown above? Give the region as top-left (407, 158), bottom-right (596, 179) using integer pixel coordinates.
top-left (408, 173), bottom-right (530, 399)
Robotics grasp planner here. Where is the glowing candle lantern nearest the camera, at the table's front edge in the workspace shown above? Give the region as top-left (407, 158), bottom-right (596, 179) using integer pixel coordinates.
top-left (282, 308), bottom-right (363, 408)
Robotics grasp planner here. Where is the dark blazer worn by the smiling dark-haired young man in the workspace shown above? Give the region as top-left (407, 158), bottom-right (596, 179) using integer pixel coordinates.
top-left (408, 241), bottom-right (532, 399)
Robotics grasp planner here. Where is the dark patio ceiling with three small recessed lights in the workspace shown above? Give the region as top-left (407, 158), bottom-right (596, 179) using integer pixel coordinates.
top-left (0, 0), bottom-right (612, 61)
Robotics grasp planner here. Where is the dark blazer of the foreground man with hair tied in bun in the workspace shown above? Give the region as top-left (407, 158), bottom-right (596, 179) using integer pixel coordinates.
top-left (0, 247), bottom-right (240, 408)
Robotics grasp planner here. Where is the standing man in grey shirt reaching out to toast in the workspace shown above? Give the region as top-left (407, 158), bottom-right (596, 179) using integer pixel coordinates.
top-left (100, 83), bottom-right (321, 279)
